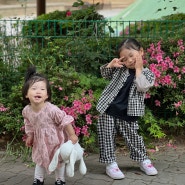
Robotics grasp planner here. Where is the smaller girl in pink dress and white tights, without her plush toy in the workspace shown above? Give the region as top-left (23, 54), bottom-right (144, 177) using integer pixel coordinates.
top-left (22, 67), bottom-right (78, 185)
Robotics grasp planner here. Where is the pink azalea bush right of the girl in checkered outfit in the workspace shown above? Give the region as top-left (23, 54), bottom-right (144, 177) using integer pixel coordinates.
top-left (145, 39), bottom-right (185, 126)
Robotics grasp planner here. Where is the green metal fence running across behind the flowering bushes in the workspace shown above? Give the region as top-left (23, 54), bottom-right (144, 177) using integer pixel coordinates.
top-left (0, 20), bottom-right (185, 68)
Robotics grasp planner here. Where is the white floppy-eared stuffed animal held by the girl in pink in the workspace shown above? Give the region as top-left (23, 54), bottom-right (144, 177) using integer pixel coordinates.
top-left (48, 140), bottom-right (87, 177)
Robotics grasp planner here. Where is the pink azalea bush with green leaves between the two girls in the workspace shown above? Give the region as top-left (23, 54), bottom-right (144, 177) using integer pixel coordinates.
top-left (47, 69), bottom-right (106, 151)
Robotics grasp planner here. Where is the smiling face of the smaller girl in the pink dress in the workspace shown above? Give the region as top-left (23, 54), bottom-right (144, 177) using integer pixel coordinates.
top-left (26, 81), bottom-right (48, 105)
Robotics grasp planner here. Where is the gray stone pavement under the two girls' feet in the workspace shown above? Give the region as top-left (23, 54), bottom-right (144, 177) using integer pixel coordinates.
top-left (0, 145), bottom-right (185, 185)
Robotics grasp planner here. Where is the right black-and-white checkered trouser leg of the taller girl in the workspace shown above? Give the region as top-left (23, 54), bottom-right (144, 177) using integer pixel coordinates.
top-left (117, 119), bottom-right (148, 161)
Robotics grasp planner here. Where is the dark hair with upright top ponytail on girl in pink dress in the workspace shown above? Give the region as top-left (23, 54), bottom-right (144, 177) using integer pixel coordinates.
top-left (22, 66), bottom-right (51, 104)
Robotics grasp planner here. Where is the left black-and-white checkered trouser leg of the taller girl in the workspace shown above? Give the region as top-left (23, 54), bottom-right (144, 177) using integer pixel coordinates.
top-left (97, 114), bottom-right (116, 163)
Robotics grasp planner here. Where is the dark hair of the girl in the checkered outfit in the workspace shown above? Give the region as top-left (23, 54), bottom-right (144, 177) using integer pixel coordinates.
top-left (118, 38), bottom-right (142, 57)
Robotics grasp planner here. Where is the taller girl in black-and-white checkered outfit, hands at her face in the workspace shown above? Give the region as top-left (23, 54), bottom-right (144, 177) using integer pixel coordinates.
top-left (97, 38), bottom-right (158, 179)
